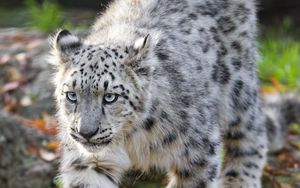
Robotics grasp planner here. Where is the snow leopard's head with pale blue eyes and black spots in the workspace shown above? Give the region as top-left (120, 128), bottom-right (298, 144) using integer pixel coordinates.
top-left (54, 30), bottom-right (150, 151)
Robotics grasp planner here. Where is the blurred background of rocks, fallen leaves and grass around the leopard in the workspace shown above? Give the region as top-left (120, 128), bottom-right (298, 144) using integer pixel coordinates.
top-left (0, 0), bottom-right (300, 188)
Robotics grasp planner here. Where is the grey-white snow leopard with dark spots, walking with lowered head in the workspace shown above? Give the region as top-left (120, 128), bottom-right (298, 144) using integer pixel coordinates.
top-left (52, 0), bottom-right (300, 188)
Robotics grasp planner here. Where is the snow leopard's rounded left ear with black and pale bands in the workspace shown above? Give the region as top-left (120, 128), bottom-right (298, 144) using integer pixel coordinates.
top-left (52, 30), bottom-right (82, 60)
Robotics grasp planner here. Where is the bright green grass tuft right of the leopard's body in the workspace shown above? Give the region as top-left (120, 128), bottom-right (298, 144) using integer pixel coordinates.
top-left (258, 19), bottom-right (300, 90)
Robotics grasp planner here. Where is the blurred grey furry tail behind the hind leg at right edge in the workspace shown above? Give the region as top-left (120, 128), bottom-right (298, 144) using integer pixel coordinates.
top-left (262, 94), bottom-right (300, 151)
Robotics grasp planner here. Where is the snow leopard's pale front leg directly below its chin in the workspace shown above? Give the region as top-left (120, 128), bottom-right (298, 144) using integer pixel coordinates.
top-left (61, 148), bottom-right (130, 188)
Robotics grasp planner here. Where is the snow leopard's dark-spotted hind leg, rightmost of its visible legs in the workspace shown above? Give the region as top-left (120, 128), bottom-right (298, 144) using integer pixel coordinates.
top-left (221, 100), bottom-right (267, 188)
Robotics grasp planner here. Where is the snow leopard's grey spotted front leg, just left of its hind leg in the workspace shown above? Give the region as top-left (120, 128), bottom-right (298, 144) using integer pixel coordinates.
top-left (167, 133), bottom-right (221, 188)
